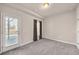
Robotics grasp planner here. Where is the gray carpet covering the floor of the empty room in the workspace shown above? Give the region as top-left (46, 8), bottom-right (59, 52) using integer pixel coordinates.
top-left (3, 39), bottom-right (79, 55)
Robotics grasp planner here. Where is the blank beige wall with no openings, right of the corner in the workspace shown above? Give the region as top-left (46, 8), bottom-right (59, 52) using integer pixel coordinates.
top-left (43, 10), bottom-right (76, 44)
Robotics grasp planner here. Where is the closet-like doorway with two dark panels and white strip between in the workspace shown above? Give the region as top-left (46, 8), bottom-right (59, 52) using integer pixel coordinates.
top-left (33, 20), bottom-right (42, 41)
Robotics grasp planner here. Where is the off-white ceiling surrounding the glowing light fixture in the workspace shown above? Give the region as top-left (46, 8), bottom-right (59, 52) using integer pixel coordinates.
top-left (3, 3), bottom-right (77, 18)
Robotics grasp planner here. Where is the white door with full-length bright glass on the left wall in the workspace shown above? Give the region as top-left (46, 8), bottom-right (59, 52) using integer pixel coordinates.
top-left (3, 16), bottom-right (19, 52)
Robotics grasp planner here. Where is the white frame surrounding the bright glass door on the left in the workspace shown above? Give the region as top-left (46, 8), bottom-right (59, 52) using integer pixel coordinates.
top-left (1, 12), bottom-right (21, 53)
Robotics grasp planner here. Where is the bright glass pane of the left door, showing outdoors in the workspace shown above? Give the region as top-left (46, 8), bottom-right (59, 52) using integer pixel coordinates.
top-left (5, 17), bottom-right (18, 46)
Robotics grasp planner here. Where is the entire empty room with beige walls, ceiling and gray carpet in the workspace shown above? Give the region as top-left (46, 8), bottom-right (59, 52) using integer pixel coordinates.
top-left (0, 3), bottom-right (79, 55)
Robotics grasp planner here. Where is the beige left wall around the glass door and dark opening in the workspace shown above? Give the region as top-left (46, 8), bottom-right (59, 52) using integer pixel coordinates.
top-left (1, 6), bottom-right (42, 51)
